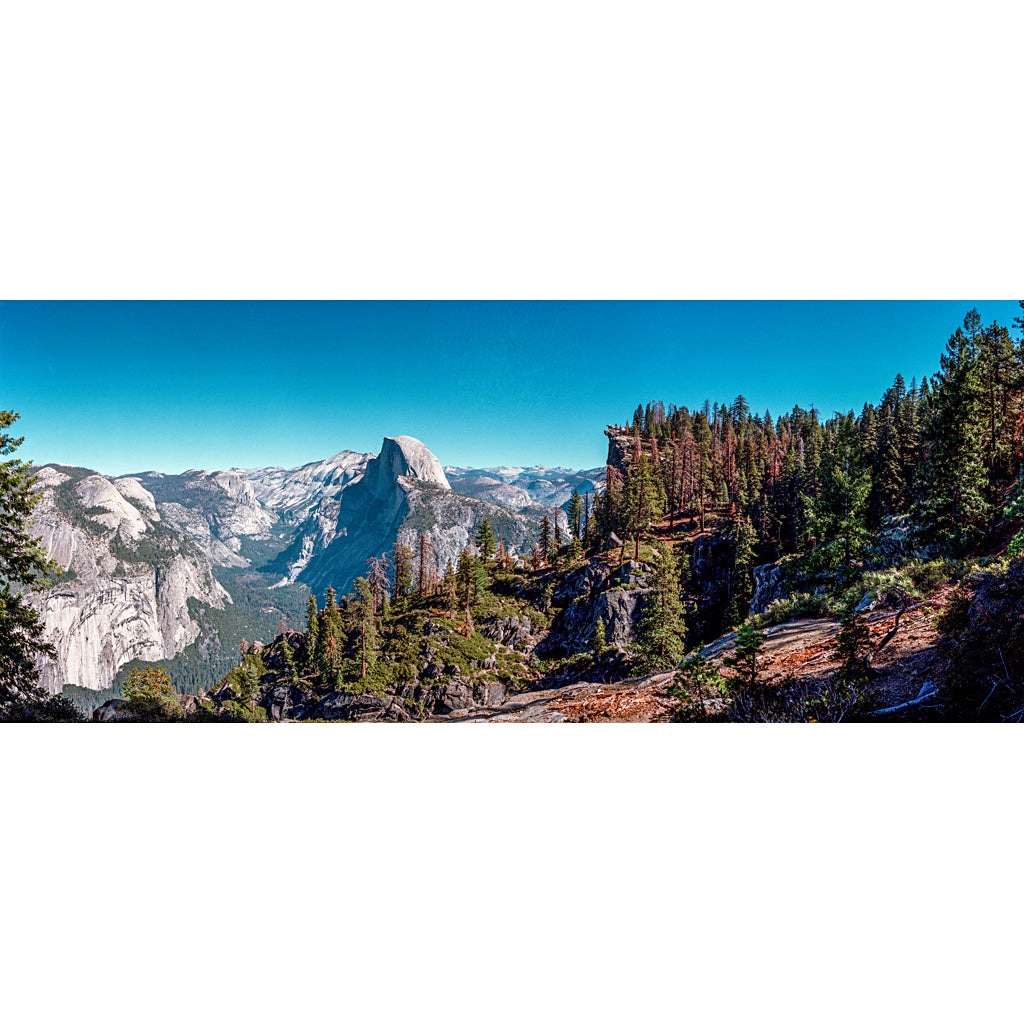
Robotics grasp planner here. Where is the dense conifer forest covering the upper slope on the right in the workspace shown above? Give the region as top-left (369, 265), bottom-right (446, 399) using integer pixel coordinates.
top-left (595, 304), bottom-right (1024, 616)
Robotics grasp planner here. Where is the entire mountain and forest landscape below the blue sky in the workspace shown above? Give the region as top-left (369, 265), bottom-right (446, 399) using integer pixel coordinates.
top-left (6, 299), bottom-right (1024, 722)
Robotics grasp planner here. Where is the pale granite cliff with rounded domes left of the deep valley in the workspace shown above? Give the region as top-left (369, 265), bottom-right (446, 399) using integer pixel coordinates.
top-left (25, 466), bottom-right (230, 692)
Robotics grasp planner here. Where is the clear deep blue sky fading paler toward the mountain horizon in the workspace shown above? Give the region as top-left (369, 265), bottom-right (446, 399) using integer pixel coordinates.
top-left (0, 300), bottom-right (1020, 475)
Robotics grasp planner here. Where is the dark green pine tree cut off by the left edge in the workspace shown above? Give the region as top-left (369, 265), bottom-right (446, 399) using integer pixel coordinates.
top-left (0, 411), bottom-right (59, 714)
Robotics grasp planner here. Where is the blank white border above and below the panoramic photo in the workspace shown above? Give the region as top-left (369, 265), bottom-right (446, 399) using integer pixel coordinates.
top-left (0, 0), bottom-right (1024, 1024)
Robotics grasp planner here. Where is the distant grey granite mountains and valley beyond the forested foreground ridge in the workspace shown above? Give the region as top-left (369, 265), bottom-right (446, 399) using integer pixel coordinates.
top-left (28, 437), bottom-right (604, 693)
